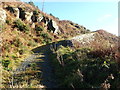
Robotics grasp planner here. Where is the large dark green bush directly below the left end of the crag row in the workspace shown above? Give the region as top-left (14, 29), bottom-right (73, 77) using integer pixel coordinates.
top-left (14, 19), bottom-right (30, 31)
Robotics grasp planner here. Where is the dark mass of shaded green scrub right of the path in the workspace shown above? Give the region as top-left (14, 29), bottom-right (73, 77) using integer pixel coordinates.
top-left (50, 47), bottom-right (120, 88)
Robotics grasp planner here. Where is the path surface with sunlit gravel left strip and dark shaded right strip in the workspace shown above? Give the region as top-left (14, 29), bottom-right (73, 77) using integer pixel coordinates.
top-left (14, 45), bottom-right (56, 88)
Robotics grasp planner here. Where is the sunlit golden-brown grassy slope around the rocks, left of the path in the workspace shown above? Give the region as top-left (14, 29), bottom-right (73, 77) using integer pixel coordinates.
top-left (0, 3), bottom-right (119, 87)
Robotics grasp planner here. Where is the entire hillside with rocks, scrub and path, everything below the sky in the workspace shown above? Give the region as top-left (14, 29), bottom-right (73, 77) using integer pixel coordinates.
top-left (0, 0), bottom-right (120, 88)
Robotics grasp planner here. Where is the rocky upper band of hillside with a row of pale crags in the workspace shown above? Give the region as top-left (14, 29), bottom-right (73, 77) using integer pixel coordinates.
top-left (2, 2), bottom-right (90, 38)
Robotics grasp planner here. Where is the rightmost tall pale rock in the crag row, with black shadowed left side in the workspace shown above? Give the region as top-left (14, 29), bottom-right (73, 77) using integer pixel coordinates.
top-left (47, 19), bottom-right (60, 34)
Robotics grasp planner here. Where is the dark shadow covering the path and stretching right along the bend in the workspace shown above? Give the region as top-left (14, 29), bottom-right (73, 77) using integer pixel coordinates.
top-left (32, 40), bottom-right (72, 88)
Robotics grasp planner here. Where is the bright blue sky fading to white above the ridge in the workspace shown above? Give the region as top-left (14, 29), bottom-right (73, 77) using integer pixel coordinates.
top-left (21, 0), bottom-right (118, 35)
